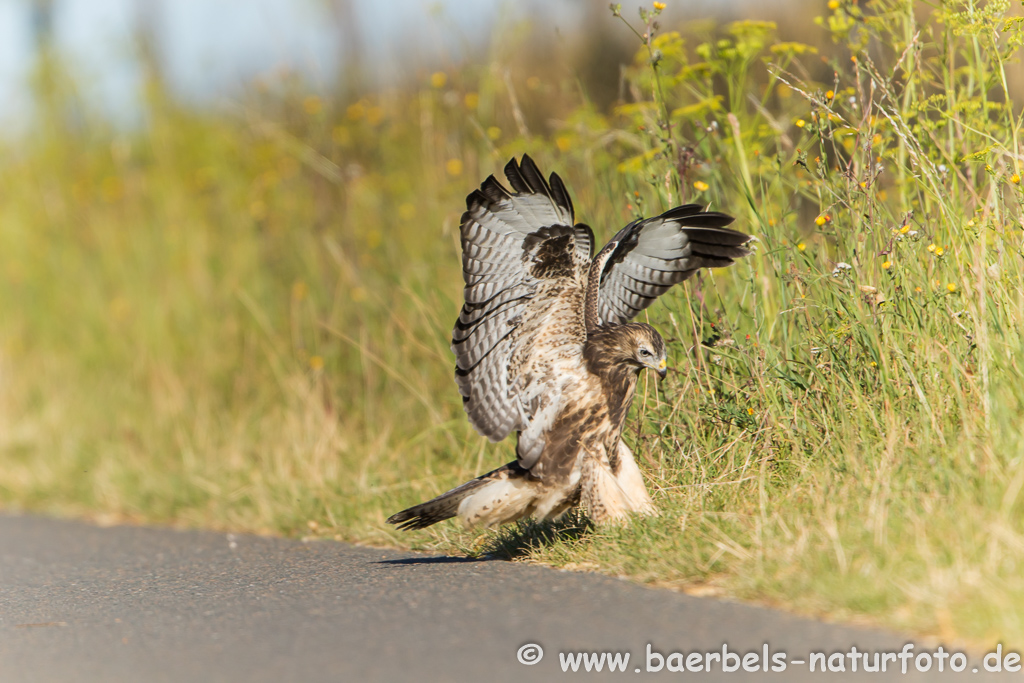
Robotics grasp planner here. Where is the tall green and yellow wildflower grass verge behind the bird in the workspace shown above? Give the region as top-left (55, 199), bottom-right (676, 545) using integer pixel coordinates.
top-left (6, 0), bottom-right (1024, 646)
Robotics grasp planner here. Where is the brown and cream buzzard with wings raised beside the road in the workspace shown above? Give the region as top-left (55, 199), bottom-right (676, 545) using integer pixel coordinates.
top-left (388, 156), bottom-right (752, 529)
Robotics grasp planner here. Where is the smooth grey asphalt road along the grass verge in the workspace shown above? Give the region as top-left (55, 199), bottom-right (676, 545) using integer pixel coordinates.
top-left (0, 515), bottom-right (1024, 683)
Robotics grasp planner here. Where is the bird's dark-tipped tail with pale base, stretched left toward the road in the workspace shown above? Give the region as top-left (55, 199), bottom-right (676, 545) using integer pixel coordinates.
top-left (387, 462), bottom-right (528, 529)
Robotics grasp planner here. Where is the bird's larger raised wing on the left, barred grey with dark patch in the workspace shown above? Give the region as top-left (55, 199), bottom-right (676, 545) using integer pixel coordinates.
top-left (452, 156), bottom-right (594, 468)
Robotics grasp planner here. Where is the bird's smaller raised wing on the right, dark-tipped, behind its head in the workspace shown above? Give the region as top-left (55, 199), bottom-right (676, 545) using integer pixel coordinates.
top-left (594, 204), bottom-right (753, 325)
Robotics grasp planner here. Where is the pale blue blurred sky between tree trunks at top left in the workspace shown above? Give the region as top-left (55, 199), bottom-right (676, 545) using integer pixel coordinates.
top-left (0, 0), bottom-right (507, 127)
